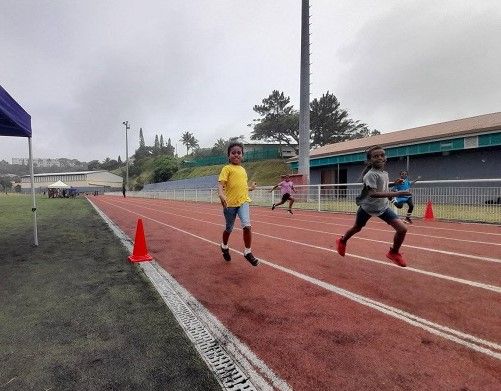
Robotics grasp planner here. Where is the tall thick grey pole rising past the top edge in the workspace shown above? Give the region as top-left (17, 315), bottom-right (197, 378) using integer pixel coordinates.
top-left (298, 0), bottom-right (310, 185)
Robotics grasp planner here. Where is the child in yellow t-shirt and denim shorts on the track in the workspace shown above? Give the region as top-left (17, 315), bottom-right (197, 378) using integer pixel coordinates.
top-left (218, 142), bottom-right (259, 266)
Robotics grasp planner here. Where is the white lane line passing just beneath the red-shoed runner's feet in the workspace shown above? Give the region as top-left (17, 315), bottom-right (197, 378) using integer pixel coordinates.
top-left (107, 198), bottom-right (501, 293)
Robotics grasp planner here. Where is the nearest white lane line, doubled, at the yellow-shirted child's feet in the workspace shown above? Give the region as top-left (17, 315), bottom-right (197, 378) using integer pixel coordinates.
top-left (95, 198), bottom-right (501, 360)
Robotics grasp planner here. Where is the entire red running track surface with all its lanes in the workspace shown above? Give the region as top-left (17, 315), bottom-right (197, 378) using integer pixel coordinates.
top-left (91, 196), bottom-right (501, 390)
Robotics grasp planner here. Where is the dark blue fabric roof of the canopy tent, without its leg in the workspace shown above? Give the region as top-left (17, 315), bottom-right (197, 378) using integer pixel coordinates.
top-left (0, 85), bottom-right (31, 137)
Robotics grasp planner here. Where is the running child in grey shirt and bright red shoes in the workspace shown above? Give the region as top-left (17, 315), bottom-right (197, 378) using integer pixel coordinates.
top-left (336, 145), bottom-right (411, 267)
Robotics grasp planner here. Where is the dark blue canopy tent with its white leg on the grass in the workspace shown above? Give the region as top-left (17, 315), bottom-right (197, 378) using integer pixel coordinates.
top-left (0, 85), bottom-right (38, 246)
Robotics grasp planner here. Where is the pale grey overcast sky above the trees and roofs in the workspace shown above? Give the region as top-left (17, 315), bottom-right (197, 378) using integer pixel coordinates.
top-left (0, 0), bottom-right (501, 163)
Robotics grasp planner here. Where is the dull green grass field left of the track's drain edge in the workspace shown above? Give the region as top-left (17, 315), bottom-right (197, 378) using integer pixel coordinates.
top-left (0, 195), bottom-right (221, 391)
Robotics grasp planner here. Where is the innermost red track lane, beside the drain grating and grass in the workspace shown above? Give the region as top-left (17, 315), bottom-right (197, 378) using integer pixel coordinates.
top-left (91, 198), bottom-right (499, 390)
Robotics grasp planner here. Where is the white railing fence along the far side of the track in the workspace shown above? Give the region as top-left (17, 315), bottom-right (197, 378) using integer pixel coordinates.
top-left (106, 179), bottom-right (501, 224)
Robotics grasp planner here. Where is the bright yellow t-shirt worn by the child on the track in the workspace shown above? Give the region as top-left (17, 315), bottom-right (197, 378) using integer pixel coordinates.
top-left (219, 164), bottom-right (251, 208)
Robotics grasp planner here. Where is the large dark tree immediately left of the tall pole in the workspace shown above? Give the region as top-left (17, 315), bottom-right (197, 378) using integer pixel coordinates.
top-left (249, 90), bottom-right (299, 146)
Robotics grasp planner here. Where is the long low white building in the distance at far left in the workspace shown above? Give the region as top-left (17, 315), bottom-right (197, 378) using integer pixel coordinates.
top-left (21, 170), bottom-right (123, 191)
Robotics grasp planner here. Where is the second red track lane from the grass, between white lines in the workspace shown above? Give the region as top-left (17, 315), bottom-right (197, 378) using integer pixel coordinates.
top-left (94, 196), bottom-right (501, 346)
